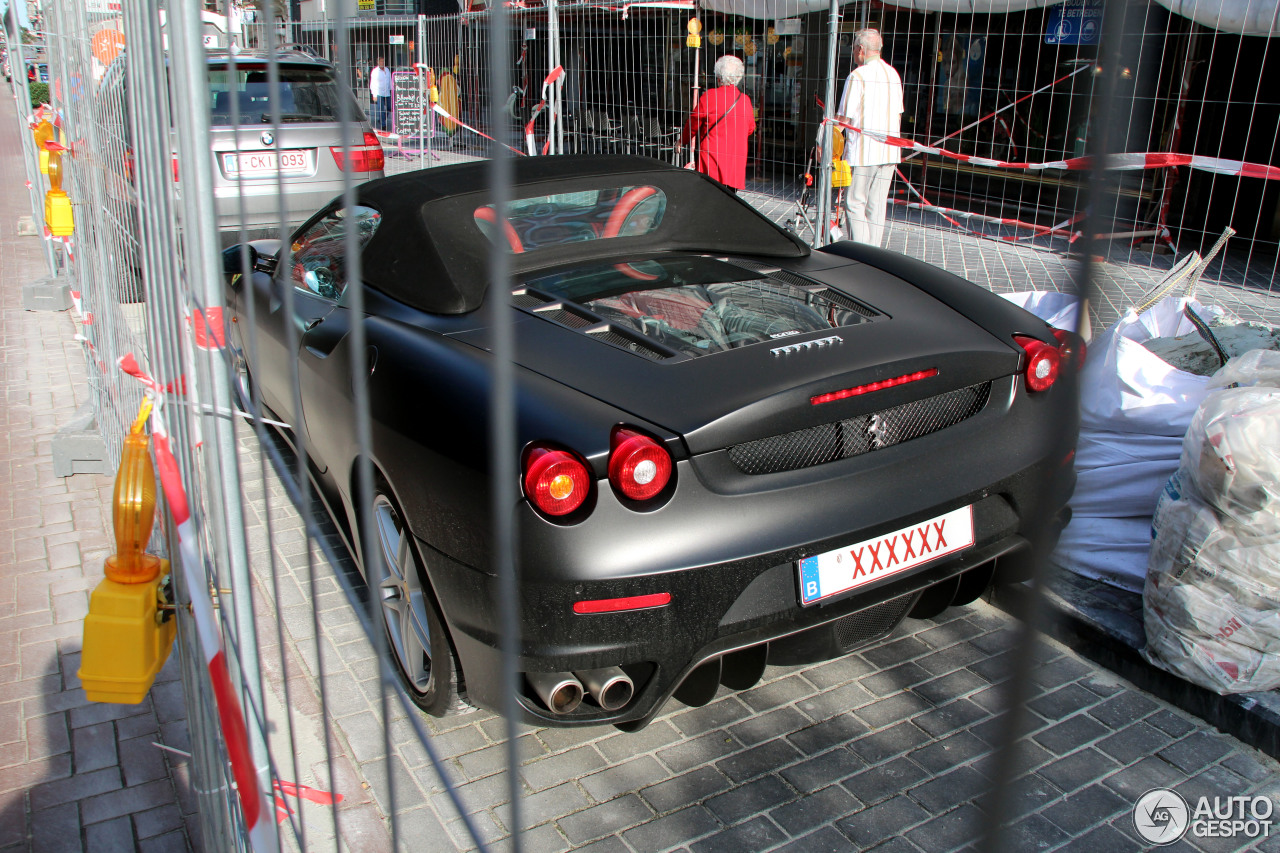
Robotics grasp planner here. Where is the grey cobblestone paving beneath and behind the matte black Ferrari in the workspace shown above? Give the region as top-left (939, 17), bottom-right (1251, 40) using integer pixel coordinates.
top-left (242, 420), bottom-right (1280, 853)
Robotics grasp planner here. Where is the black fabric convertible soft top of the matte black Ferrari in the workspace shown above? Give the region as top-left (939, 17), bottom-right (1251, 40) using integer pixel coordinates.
top-left (356, 155), bottom-right (809, 314)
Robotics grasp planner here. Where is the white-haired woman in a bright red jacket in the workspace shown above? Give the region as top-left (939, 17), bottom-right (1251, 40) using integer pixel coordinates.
top-left (680, 56), bottom-right (755, 190)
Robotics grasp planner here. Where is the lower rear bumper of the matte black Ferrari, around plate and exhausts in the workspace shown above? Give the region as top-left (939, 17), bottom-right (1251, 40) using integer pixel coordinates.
top-left (420, 450), bottom-right (1074, 727)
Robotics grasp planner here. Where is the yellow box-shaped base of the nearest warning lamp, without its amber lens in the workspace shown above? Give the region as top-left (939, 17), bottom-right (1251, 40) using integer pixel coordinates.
top-left (77, 560), bottom-right (177, 704)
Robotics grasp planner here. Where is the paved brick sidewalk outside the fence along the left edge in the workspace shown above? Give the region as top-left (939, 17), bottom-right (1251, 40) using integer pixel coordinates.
top-left (0, 84), bottom-right (198, 853)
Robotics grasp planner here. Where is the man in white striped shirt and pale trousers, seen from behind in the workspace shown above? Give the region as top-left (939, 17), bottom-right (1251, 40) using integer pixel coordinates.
top-left (840, 29), bottom-right (902, 246)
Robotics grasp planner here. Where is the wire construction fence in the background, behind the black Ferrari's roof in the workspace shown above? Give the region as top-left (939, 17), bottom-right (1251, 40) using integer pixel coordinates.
top-left (259, 0), bottom-right (1280, 325)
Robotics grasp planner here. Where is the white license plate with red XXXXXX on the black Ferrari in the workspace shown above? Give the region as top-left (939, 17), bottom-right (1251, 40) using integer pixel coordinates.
top-left (797, 506), bottom-right (973, 605)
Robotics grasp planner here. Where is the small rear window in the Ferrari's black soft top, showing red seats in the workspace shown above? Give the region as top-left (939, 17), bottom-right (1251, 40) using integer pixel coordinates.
top-left (472, 186), bottom-right (667, 254)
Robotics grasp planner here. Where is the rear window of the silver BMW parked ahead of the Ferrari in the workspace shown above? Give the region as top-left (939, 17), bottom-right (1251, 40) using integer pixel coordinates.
top-left (209, 63), bottom-right (365, 127)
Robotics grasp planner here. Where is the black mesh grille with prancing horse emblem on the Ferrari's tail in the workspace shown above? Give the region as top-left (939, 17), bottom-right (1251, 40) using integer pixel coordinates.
top-left (728, 382), bottom-right (991, 474)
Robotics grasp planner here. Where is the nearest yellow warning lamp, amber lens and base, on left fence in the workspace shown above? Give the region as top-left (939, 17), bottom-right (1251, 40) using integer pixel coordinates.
top-left (77, 401), bottom-right (177, 704)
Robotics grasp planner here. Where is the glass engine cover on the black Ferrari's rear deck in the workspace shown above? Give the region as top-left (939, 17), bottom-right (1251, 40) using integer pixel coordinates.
top-left (525, 256), bottom-right (876, 356)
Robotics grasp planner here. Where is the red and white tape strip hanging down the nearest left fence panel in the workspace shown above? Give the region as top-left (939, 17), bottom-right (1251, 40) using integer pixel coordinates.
top-left (119, 352), bottom-right (279, 853)
